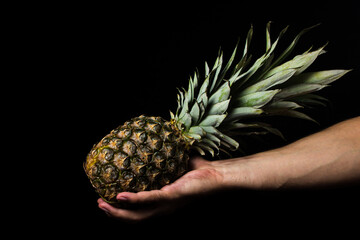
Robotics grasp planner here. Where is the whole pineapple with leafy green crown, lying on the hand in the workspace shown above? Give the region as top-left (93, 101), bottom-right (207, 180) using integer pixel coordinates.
top-left (84, 23), bottom-right (348, 203)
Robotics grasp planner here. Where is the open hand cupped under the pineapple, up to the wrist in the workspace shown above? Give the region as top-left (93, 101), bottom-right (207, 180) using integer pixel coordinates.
top-left (98, 157), bottom-right (222, 221)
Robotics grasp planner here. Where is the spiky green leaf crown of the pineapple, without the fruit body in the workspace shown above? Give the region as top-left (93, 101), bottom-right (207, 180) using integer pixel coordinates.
top-left (170, 22), bottom-right (350, 156)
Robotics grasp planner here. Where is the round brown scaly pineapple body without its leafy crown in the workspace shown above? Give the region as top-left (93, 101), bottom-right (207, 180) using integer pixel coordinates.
top-left (84, 115), bottom-right (189, 203)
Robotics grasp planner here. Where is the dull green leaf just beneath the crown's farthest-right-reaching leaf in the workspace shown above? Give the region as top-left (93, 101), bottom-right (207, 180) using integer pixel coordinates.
top-left (274, 83), bottom-right (326, 99)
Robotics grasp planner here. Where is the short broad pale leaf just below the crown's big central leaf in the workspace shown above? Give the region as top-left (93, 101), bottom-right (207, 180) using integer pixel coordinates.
top-left (234, 89), bottom-right (280, 108)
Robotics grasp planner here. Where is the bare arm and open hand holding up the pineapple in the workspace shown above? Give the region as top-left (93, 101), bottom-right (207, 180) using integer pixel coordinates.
top-left (98, 117), bottom-right (360, 221)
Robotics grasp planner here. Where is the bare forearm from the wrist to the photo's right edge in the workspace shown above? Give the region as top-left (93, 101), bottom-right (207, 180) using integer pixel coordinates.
top-left (218, 117), bottom-right (360, 188)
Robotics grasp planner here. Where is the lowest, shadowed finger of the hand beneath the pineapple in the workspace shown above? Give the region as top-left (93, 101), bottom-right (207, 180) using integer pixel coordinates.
top-left (98, 199), bottom-right (160, 222)
